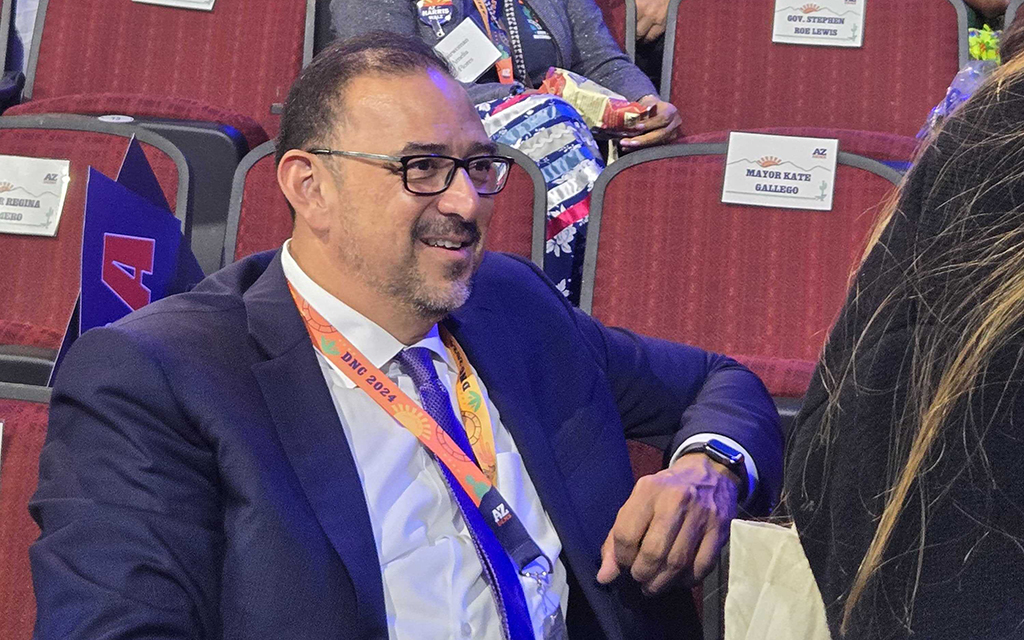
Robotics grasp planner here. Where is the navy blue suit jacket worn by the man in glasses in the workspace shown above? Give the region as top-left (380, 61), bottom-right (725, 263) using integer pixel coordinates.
top-left (31, 253), bottom-right (782, 640)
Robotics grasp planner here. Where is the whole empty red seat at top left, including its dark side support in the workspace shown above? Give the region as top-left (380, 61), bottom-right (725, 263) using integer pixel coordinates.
top-left (8, 0), bottom-right (315, 272)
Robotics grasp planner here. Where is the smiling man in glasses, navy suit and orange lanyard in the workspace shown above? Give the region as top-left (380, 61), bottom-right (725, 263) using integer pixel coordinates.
top-left (31, 35), bottom-right (782, 640)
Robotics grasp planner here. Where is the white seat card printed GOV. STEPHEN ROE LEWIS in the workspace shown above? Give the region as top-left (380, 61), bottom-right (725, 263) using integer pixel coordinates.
top-left (771, 0), bottom-right (867, 47)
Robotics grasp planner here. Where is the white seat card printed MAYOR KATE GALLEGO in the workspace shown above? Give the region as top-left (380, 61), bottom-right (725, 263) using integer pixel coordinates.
top-left (722, 132), bottom-right (839, 211)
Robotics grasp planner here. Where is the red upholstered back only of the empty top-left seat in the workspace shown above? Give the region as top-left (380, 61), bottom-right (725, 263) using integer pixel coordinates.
top-left (24, 0), bottom-right (314, 136)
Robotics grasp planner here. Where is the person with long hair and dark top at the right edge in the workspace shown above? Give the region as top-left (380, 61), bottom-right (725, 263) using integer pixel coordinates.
top-left (786, 51), bottom-right (1024, 640)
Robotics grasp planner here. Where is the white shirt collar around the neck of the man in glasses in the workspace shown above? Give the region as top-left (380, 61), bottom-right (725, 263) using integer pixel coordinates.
top-left (281, 240), bottom-right (456, 388)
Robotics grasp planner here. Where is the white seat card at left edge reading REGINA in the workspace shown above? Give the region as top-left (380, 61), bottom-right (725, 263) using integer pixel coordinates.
top-left (0, 156), bottom-right (71, 238)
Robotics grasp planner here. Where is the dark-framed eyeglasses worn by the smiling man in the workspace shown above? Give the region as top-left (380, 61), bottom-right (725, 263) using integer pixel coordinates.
top-left (306, 148), bottom-right (512, 196)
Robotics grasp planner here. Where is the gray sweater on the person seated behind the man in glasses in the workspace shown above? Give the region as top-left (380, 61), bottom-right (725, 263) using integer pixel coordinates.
top-left (331, 0), bottom-right (657, 103)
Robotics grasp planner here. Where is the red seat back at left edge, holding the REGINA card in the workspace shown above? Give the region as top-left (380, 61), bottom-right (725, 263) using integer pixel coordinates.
top-left (0, 116), bottom-right (189, 349)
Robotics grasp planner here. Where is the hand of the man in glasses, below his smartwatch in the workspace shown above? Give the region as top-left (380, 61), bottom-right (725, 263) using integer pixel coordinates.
top-left (597, 453), bottom-right (739, 595)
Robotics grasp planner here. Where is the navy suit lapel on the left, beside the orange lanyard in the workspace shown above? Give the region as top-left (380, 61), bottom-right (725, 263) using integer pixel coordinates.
top-left (244, 254), bottom-right (387, 637)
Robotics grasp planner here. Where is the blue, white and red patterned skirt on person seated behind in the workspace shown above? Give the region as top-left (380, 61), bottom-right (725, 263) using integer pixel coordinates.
top-left (476, 94), bottom-right (604, 304)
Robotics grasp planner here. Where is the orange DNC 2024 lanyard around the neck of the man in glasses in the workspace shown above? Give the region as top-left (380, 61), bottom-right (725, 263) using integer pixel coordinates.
top-left (288, 284), bottom-right (498, 499)
